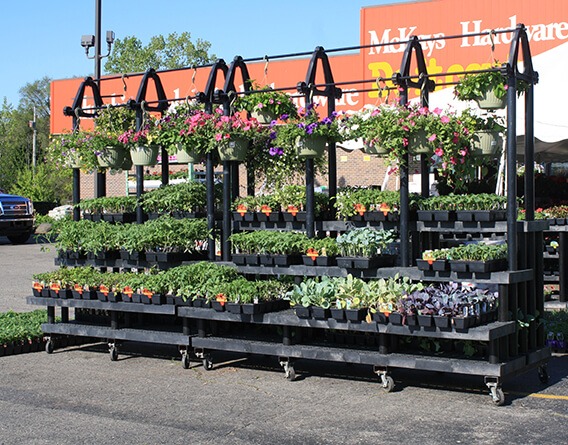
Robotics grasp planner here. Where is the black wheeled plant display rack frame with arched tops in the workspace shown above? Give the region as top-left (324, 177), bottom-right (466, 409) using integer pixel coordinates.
top-left (28, 25), bottom-right (550, 405)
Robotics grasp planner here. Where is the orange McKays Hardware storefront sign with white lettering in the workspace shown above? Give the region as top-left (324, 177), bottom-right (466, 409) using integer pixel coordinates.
top-left (51, 0), bottom-right (568, 133)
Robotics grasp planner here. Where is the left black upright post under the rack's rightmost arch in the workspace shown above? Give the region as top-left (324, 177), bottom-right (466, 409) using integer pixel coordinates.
top-left (506, 67), bottom-right (518, 271)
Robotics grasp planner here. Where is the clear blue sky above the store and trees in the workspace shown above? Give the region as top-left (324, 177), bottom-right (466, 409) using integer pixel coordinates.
top-left (0, 0), bottom-right (408, 107)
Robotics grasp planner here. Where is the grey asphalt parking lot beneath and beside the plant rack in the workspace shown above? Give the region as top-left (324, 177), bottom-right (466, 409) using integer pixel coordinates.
top-left (0, 238), bottom-right (568, 445)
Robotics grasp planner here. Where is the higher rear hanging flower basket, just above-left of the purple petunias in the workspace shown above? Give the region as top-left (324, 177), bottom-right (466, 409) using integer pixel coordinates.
top-left (235, 81), bottom-right (298, 125)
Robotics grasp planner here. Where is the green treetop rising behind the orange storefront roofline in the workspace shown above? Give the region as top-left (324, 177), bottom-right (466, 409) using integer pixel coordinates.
top-left (105, 32), bottom-right (215, 74)
